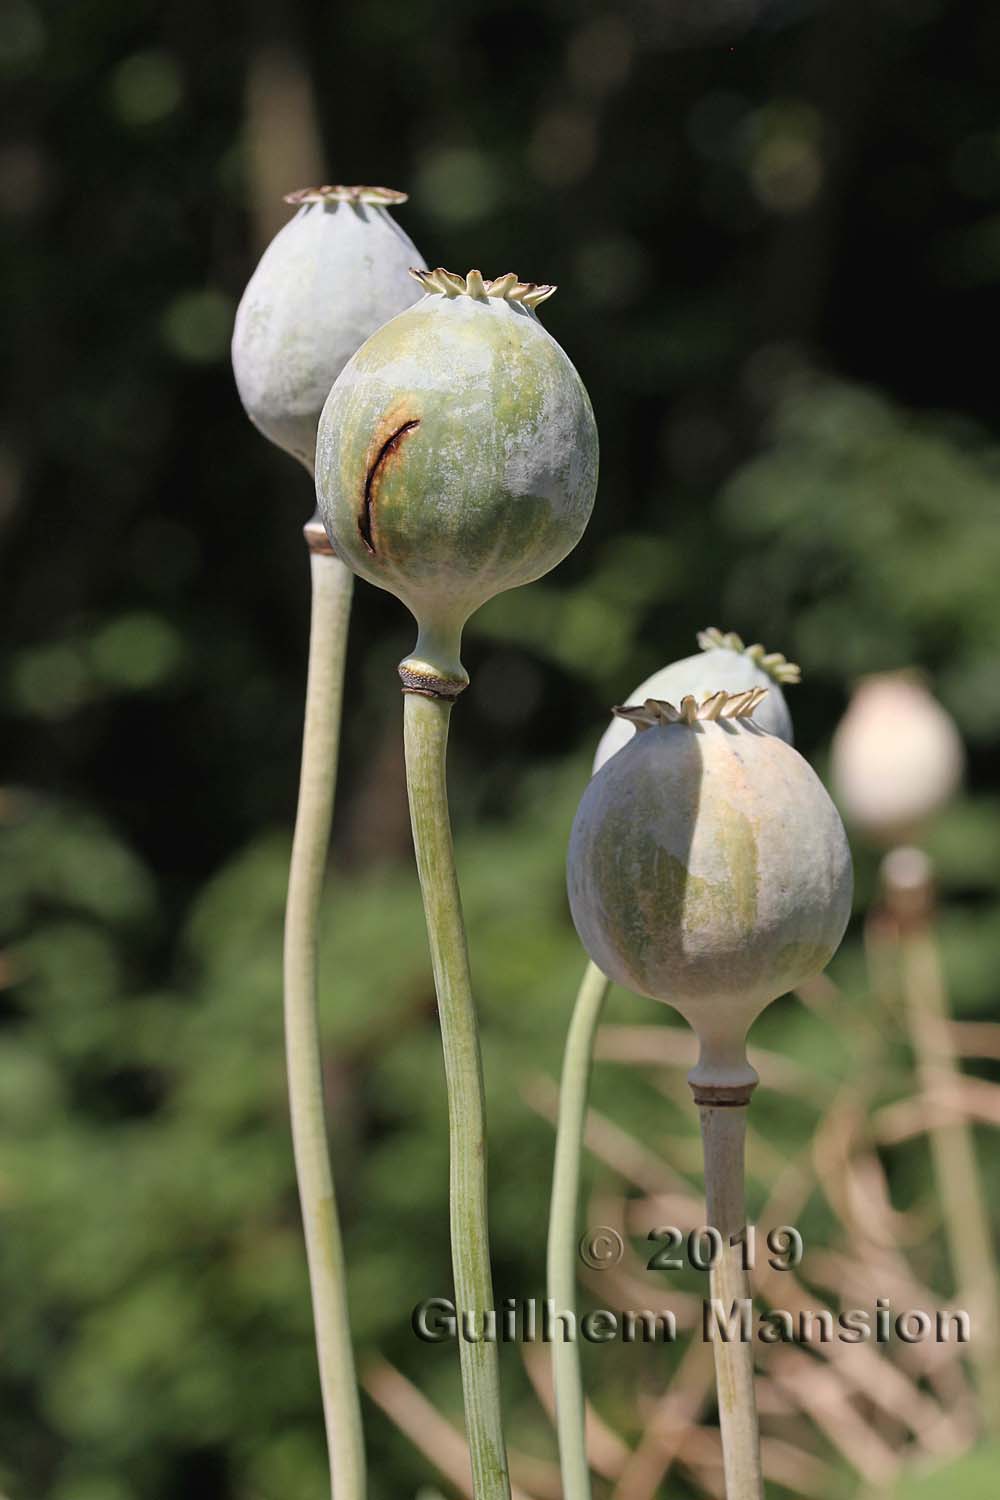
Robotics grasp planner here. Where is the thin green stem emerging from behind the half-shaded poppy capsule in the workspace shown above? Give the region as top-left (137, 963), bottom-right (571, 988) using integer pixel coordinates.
top-left (547, 963), bottom-right (610, 1500)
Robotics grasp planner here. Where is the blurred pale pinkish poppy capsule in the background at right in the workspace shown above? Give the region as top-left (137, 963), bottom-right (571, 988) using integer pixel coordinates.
top-left (831, 672), bottom-right (964, 843)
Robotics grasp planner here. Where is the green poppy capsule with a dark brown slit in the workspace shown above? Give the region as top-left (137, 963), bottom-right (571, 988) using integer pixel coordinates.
top-left (316, 270), bottom-right (597, 698)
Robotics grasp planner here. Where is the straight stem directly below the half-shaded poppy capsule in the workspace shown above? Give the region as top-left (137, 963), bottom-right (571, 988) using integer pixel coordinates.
top-left (699, 1103), bottom-right (763, 1500)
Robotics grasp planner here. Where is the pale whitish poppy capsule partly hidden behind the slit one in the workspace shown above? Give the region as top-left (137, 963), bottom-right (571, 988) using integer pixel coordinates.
top-left (232, 188), bottom-right (423, 473)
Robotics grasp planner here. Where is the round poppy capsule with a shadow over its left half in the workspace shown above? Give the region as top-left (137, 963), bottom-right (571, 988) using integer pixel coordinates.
top-left (568, 689), bottom-right (852, 1103)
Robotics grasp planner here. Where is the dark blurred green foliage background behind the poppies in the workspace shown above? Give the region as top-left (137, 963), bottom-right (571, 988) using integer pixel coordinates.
top-left (0, 0), bottom-right (1000, 1500)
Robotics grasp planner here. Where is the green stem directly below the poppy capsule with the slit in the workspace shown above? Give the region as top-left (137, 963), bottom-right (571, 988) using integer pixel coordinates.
top-left (403, 692), bottom-right (510, 1500)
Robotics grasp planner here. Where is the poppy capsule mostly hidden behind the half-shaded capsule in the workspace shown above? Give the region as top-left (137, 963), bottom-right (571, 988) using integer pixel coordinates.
top-left (594, 626), bottom-right (802, 771)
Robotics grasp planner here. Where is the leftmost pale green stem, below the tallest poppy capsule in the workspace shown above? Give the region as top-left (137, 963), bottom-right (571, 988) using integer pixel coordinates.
top-left (285, 528), bottom-right (366, 1500)
